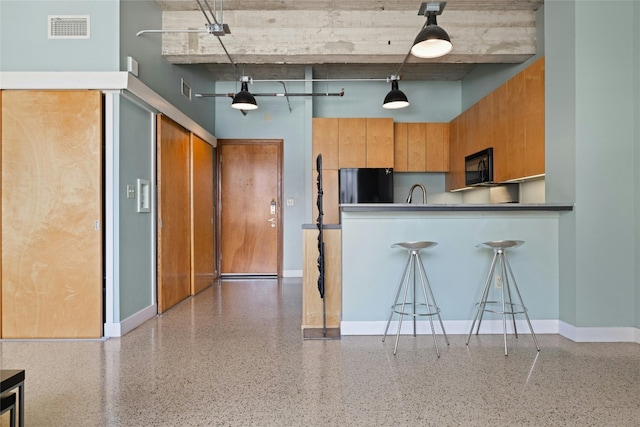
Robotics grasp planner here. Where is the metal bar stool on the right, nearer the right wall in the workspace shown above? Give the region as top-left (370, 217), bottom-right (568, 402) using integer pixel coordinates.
top-left (467, 240), bottom-right (540, 356)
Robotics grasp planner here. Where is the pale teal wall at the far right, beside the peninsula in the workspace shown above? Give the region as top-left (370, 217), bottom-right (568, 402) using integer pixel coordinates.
top-left (545, 1), bottom-right (640, 327)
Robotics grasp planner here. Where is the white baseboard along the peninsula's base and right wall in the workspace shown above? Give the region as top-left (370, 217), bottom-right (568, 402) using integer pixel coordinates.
top-left (340, 320), bottom-right (640, 344)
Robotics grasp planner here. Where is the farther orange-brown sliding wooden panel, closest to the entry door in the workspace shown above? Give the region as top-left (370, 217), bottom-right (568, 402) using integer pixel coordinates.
top-left (191, 134), bottom-right (216, 295)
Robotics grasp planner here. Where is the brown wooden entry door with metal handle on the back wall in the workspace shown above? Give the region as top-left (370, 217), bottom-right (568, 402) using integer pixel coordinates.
top-left (217, 140), bottom-right (282, 275)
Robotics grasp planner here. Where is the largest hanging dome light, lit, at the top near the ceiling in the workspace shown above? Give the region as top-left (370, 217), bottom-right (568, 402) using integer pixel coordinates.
top-left (411, 1), bottom-right (453, 58)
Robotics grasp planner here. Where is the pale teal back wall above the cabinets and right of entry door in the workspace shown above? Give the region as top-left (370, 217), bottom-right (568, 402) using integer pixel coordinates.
top-left (214, 77), bottom-right (461, 271)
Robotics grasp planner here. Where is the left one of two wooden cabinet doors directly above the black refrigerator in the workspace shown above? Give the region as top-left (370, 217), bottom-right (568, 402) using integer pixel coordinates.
top-left (338, 118), bottom-right (367, 169)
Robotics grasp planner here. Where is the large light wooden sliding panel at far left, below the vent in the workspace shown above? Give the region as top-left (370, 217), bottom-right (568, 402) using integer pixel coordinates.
top-left (2, 91), bottom-right (103, 338)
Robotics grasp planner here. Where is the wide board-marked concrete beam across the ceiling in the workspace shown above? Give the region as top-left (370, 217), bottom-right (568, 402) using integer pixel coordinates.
top-left (152, 0), bottom-right (543, 81)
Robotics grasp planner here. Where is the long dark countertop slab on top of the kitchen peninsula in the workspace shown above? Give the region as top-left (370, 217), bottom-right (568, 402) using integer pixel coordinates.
top-left (340, 203), bottom-right (573, 212)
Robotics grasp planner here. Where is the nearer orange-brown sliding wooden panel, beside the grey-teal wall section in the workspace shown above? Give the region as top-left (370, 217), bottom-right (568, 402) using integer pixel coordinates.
top-left (157, 115), bottom-right (191, 313)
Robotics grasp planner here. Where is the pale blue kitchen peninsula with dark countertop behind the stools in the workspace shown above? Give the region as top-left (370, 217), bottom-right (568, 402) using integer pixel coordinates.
top-left (340, 203), bottom-right (573, 335)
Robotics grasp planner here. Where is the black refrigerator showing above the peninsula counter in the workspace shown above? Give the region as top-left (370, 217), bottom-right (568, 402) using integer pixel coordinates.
top-left (339, 168), bottom-right (393, 203)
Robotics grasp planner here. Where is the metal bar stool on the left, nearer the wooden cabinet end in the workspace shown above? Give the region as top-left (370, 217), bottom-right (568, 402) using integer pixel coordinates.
top-left (382, 242), bottom-right (449, 357)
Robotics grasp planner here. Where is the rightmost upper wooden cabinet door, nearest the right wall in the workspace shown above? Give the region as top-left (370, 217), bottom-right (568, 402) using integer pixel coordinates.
top-left (524, 58), bottom-right (545, 176)
